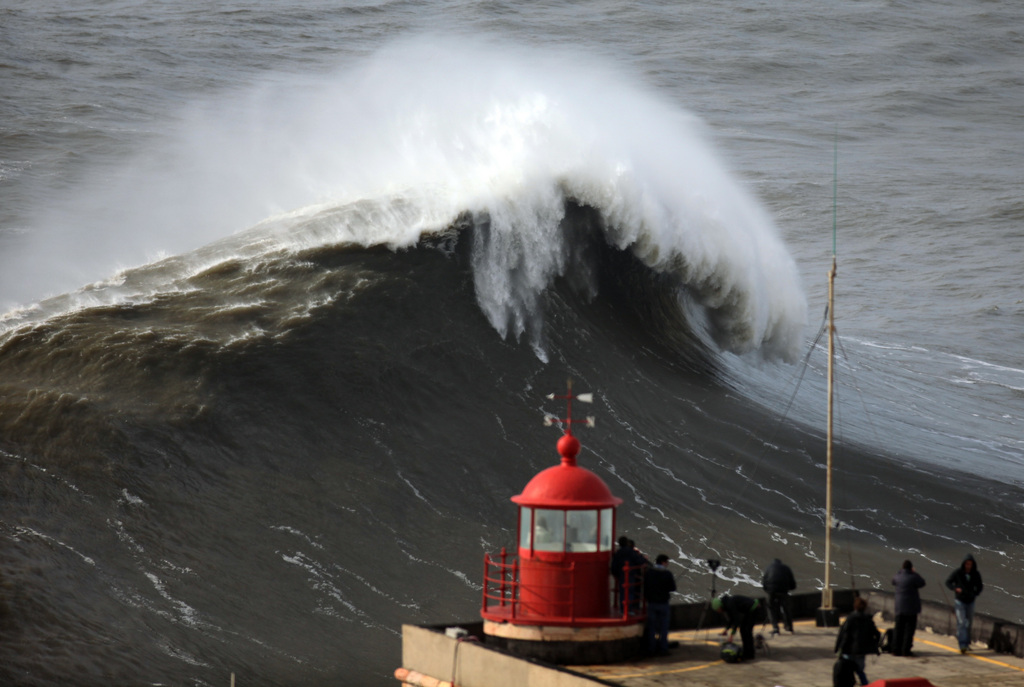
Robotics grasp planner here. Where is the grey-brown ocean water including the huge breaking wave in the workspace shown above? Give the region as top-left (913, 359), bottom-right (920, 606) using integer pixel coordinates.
top-left (0, 1), bottom-right (1024, 685)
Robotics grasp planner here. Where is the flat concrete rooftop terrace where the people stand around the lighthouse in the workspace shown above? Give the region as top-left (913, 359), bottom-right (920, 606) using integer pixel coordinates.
top-left (395, 591), bottom-right (1024, 687)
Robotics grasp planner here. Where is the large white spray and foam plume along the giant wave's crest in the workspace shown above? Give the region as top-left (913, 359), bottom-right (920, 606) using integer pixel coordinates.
top-left (0, 37), bottom-right (805, 356)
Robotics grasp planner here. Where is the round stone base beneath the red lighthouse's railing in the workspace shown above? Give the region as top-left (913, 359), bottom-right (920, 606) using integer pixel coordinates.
top-left (483, 620), bottom-right (644, 664)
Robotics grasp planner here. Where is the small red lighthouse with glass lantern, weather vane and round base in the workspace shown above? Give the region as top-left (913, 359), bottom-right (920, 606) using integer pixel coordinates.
top-left (480, 384), bottom-right (645, 662)
